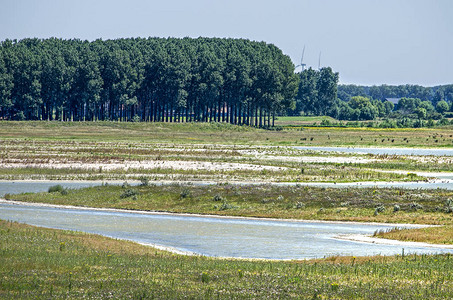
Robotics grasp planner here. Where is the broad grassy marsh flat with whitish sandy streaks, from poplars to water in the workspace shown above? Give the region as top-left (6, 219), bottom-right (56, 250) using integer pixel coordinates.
top-left (0, 122), bottom-right (453, 182)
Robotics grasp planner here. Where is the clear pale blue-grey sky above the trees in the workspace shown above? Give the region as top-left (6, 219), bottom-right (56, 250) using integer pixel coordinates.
top-left (0, 0), bottom-right (453, 86)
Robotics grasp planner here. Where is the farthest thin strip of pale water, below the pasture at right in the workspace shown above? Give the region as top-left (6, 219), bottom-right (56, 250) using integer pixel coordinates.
top-left (294, 146), bottom-right (453, 156)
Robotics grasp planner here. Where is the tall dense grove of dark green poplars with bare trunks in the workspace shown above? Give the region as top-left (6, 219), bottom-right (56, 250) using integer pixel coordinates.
top-left (0, 38), bottom-right (298, 126)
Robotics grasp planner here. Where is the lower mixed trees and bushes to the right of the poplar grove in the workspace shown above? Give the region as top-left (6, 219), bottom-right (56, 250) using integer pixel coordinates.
top-left (288, 68), bottom-right (453, 120)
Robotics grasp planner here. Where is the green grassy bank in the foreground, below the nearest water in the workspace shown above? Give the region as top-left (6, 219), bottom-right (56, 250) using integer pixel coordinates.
top-left (0, 221), bottom-right (453, 299)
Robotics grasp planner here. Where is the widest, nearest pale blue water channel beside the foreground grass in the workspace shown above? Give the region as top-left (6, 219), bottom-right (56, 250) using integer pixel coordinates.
top-left (0, 203), bottom-right (453, 259)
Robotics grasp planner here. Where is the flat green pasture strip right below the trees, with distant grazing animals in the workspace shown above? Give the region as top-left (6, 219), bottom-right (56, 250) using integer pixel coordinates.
top-left (0, 121), bottom-right (453, 148)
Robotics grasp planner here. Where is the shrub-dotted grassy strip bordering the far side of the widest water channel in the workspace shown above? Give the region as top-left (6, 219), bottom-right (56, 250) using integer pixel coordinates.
top-left (5, 184), bottom-right (453, 225)
